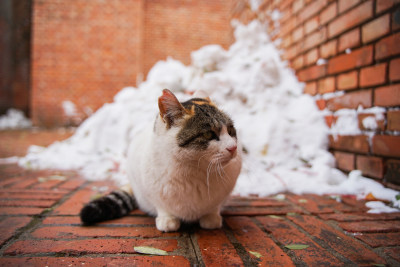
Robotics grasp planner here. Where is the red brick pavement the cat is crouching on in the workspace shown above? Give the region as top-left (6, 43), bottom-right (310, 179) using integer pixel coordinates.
top-left (0, 130), bottom-right (400, 266)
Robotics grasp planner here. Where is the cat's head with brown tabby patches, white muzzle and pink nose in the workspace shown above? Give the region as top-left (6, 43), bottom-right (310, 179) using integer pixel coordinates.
top-left (158, 89), bottom-right (238, 164)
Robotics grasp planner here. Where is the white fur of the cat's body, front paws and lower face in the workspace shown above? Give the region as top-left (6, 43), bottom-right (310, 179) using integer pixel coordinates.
top-left (128, 117), bottom-right (242, 232)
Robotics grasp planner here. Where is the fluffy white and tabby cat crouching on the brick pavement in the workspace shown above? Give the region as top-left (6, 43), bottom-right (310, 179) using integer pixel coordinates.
top-left (80, 89), bottom-right (242, 232)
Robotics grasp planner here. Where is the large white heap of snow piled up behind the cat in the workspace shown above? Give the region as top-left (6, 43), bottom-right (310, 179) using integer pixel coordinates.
top-left (20, 21), bottom-right (396, 211)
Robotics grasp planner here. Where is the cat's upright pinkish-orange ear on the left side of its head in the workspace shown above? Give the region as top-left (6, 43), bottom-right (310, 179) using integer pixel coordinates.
top-left (158, 89), bottom-right (185, 128)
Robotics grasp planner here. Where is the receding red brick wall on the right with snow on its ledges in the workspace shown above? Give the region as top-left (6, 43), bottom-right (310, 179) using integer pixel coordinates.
top-left (240, 0), bottom-right (400, 187)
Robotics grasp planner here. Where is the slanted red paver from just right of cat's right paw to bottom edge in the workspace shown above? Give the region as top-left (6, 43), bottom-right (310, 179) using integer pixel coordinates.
top-left (225, 216), bottom-right (294, 266)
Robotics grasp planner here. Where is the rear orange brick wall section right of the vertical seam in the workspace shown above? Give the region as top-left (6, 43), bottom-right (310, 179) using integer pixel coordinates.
top-left (143, 0), bottom-right (233, 73)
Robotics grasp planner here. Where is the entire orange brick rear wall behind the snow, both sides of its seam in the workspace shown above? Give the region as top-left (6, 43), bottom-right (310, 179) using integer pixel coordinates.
top-left (31, 0), bottom-right (232, 126)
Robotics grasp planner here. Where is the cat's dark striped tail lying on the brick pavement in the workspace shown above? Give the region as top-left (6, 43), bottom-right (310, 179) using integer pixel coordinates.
top-left (80, 185), bottom-right (137, 225)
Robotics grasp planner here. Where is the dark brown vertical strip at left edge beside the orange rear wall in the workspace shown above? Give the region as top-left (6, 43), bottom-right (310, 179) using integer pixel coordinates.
top-left (0, 0), bottom-right (33, 115)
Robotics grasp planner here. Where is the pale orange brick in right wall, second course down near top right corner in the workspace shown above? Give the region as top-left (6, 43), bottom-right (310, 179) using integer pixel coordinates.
top-left (361, 14), bottom-right (390, 43)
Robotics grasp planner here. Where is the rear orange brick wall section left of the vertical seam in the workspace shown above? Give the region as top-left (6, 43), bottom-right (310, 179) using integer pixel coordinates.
top-left (31, 0), bottom-right (142, 126)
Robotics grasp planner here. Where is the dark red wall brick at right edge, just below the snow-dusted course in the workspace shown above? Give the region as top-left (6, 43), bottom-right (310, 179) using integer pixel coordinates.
top-left (372, 135), bottom-right (400, 157)
